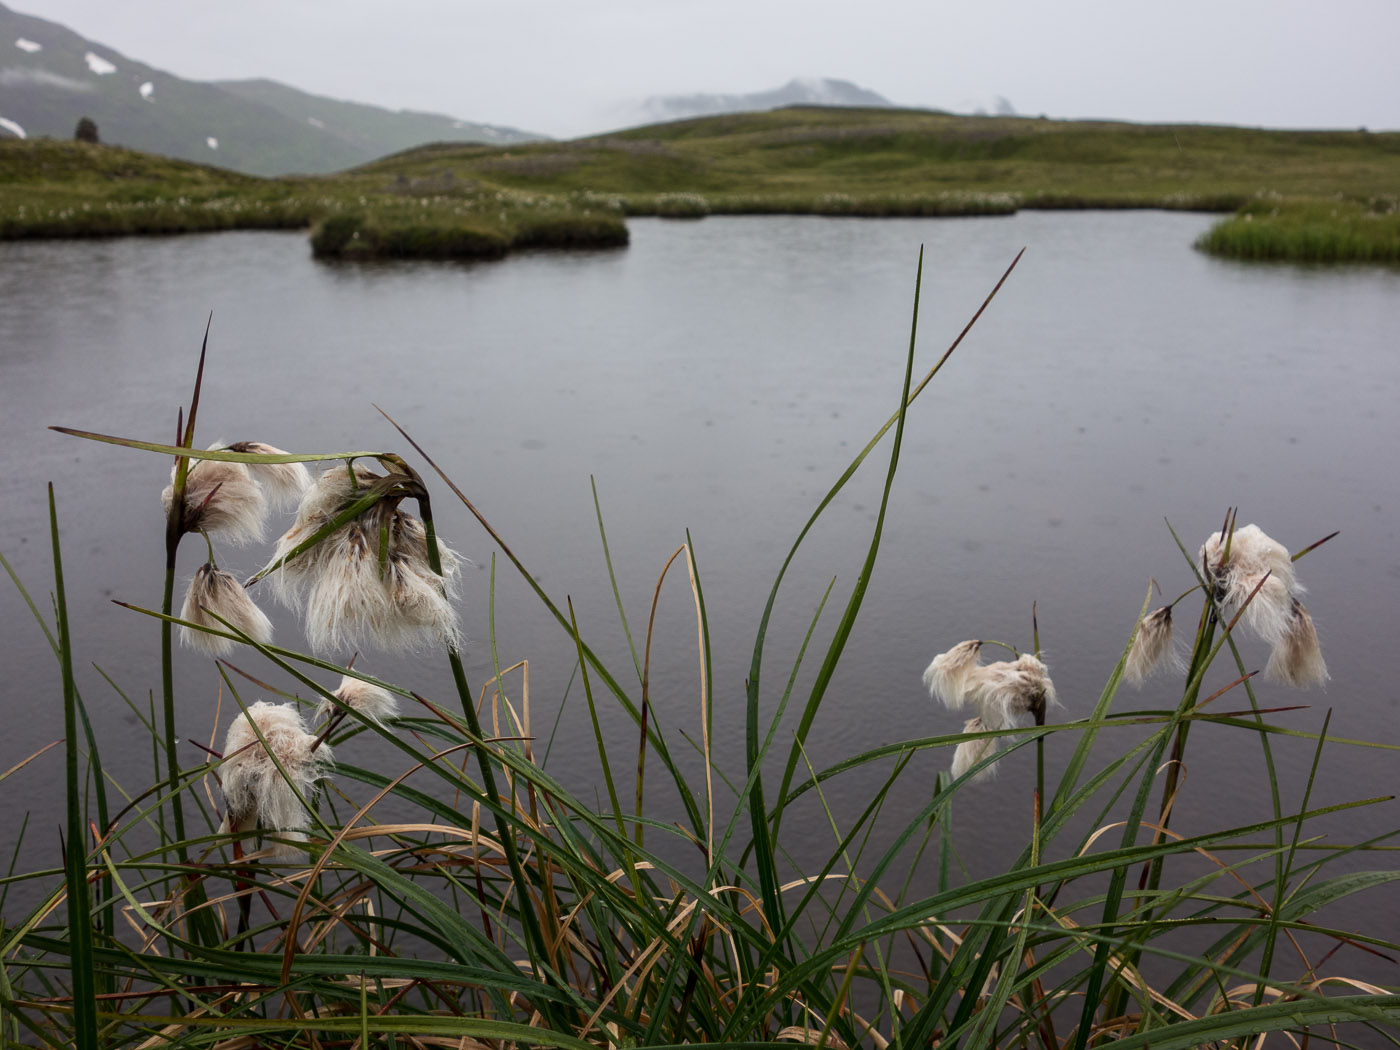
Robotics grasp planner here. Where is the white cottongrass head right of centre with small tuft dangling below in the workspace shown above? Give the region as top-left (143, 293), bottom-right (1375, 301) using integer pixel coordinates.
top-left (924, 641), bottom-right (1058, 780)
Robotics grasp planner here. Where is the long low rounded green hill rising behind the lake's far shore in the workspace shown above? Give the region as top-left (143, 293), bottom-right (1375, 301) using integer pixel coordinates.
top-left (361, 106), bottom-right (1400, 213)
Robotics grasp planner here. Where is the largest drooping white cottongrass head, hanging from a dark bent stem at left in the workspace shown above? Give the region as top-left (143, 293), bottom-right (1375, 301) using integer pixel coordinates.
top-left (270, 468), bottom-right (461, 651)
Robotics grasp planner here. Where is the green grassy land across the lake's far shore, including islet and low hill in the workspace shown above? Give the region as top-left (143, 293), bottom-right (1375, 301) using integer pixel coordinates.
top-left (0, 106), bottom-right (1400, 263)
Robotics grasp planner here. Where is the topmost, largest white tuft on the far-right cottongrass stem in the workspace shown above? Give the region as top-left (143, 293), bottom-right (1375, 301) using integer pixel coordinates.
top-left (1200, 525), bottom-right (1303, 645)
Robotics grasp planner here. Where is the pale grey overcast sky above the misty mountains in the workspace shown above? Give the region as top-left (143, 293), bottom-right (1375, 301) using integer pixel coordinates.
top-left (6, 0), bottom-right (1400, 137)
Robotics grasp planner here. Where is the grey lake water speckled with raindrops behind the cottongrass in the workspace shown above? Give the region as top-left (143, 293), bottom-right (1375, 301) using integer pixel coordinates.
top-left (0, 213), bottom-right (1400, 980)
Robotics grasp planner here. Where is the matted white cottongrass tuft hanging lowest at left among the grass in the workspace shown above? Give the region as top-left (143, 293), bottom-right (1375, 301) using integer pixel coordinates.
top-left (218, 700), bottom-right (333, 860)
